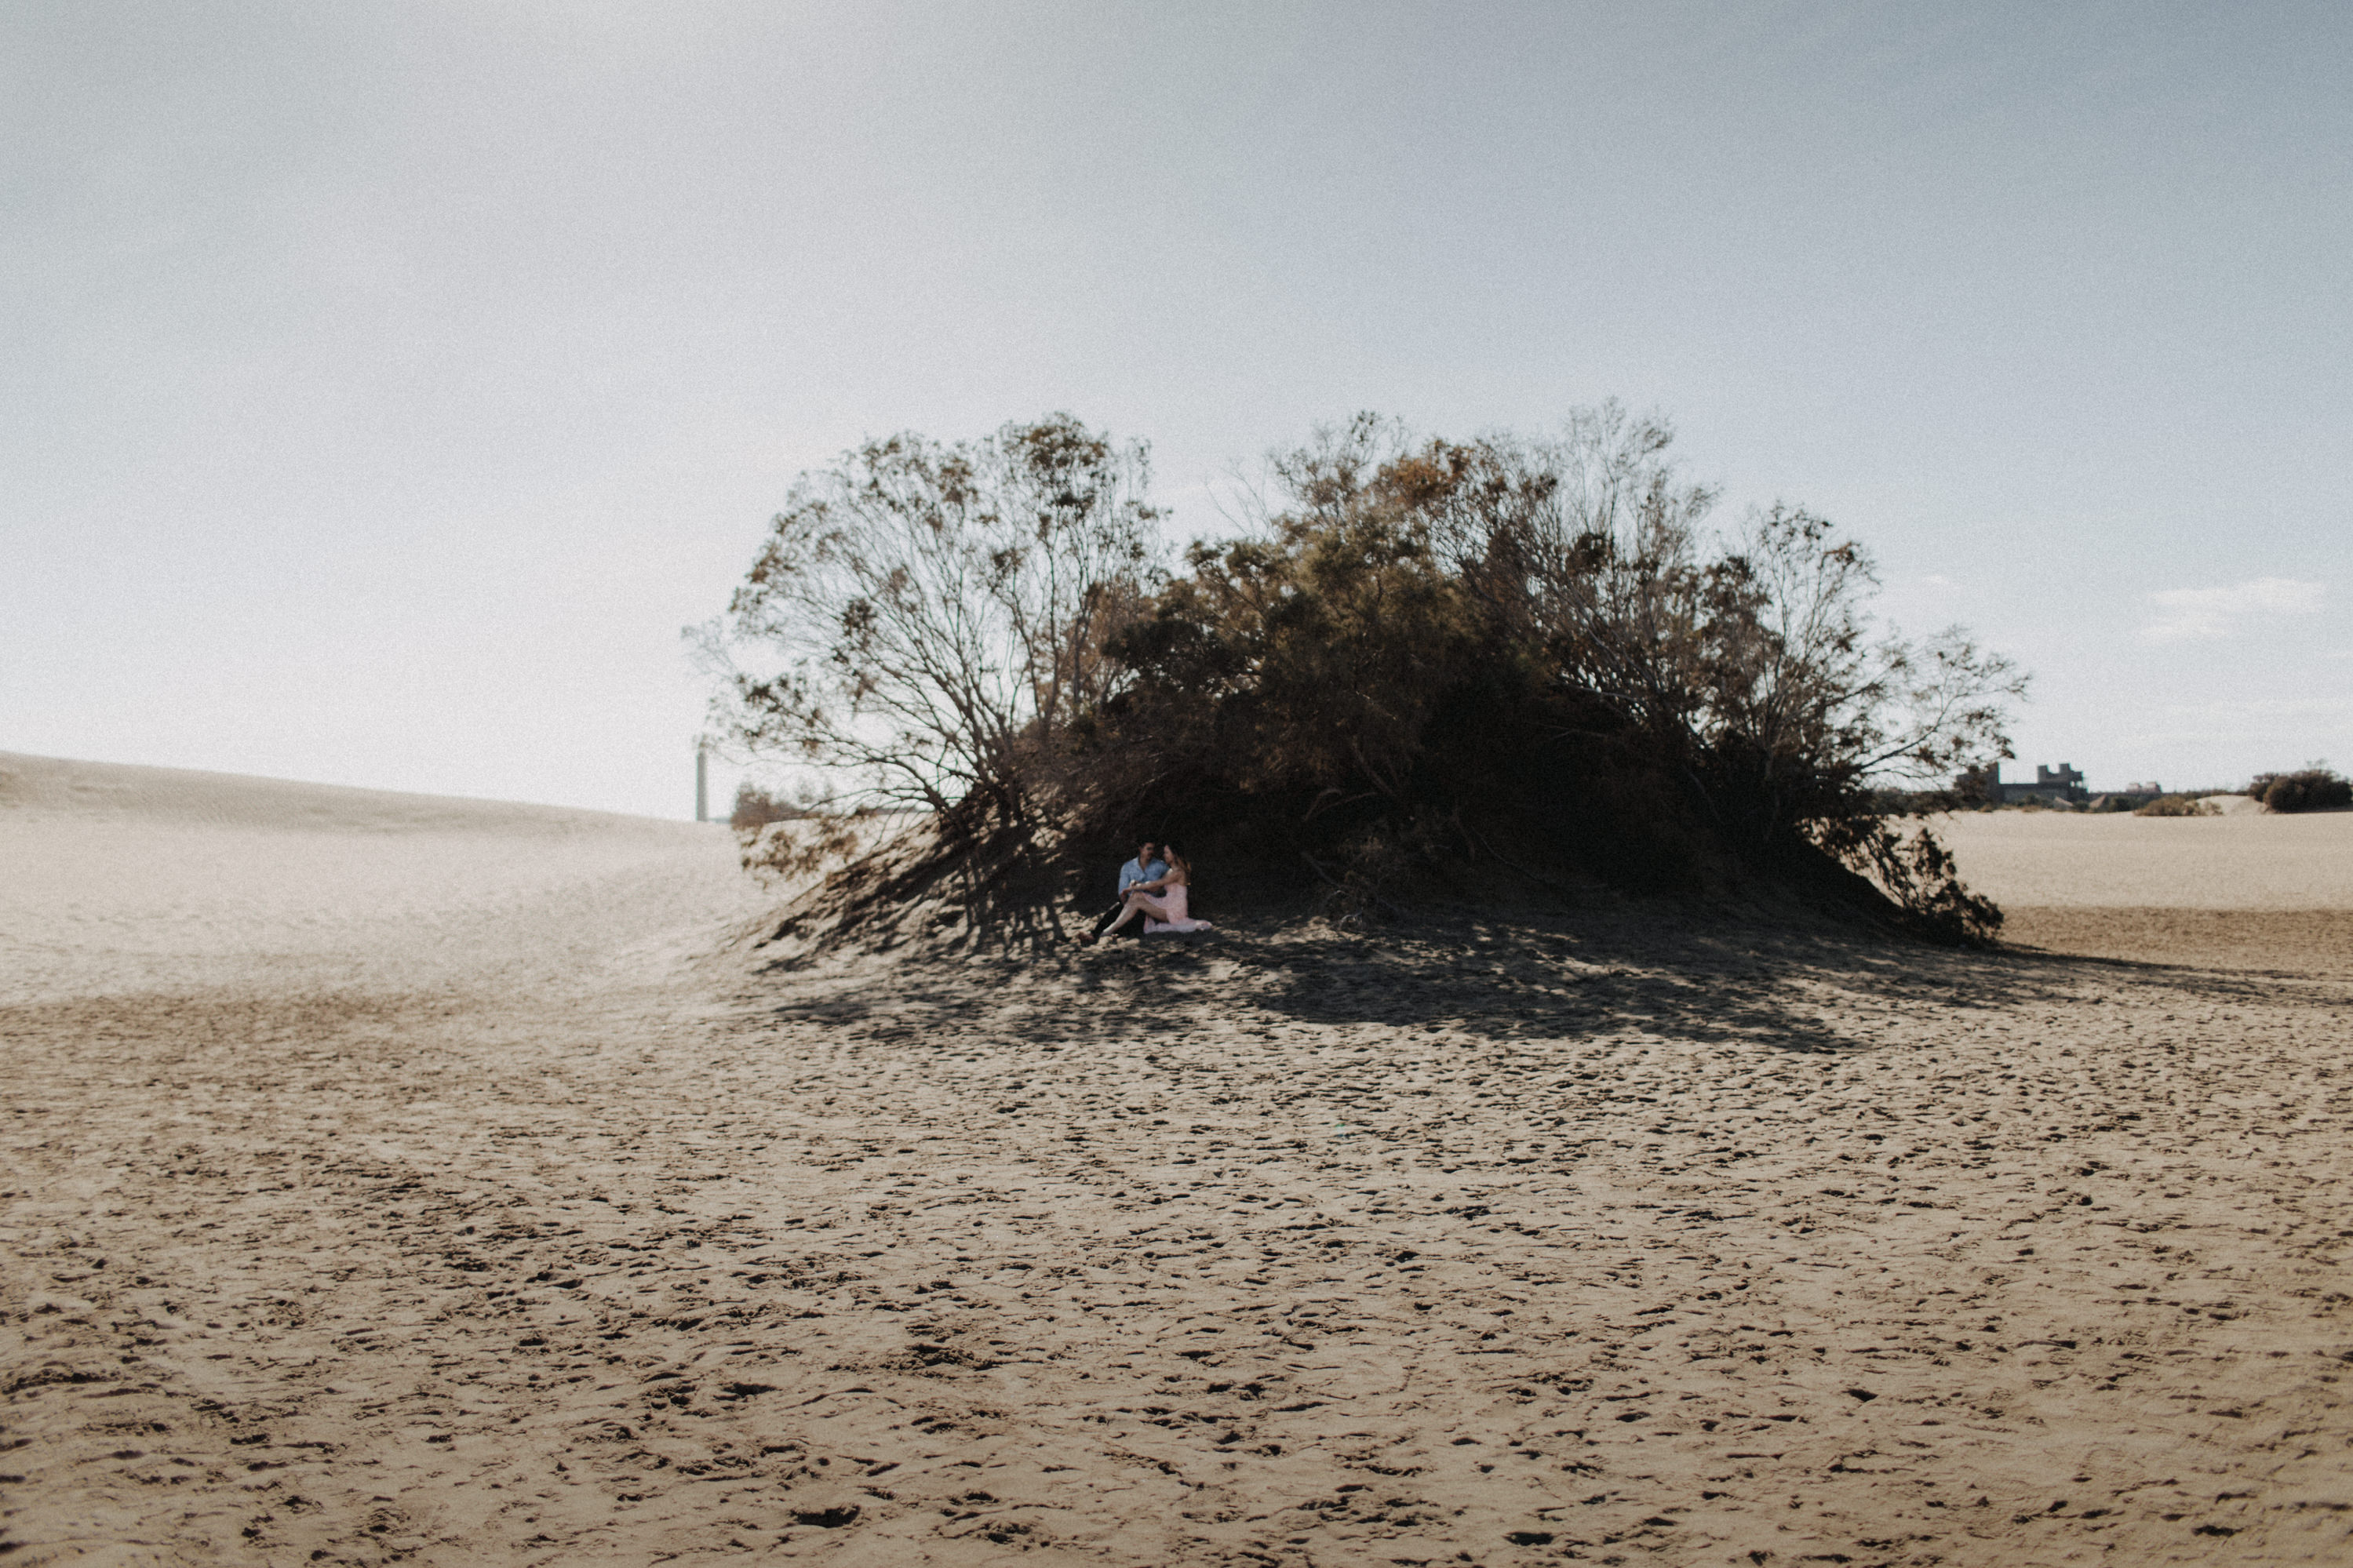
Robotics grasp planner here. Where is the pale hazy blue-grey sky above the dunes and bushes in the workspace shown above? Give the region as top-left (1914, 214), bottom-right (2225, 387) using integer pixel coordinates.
top-left (0, 0), bottom-right (2353, 816)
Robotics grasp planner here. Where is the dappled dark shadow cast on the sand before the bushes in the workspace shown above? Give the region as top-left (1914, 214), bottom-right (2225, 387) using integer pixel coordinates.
top-left (734, 888), bottom-right (2299, 1053)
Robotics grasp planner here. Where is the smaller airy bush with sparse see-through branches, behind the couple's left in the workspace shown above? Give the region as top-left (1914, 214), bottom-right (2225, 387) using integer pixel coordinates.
top-left (697, 413), bottom-right (1158, 875)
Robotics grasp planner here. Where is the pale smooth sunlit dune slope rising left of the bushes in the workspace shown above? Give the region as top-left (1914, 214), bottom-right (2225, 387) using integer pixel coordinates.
top-left (0, 752), bottom-right (758, 1002)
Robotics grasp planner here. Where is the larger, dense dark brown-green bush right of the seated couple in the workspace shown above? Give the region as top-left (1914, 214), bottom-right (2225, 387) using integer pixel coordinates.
top-left (1111, 409), bottom-right (2021, 938)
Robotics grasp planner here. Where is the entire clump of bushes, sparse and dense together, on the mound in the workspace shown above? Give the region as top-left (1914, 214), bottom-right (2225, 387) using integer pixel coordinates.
top-left (704, 406), bottom-right (2023, 940)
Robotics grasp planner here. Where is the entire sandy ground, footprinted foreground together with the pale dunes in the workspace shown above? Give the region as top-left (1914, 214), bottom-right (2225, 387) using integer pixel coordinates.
top-left (0, 757), bottom-right (2353, 1568)
